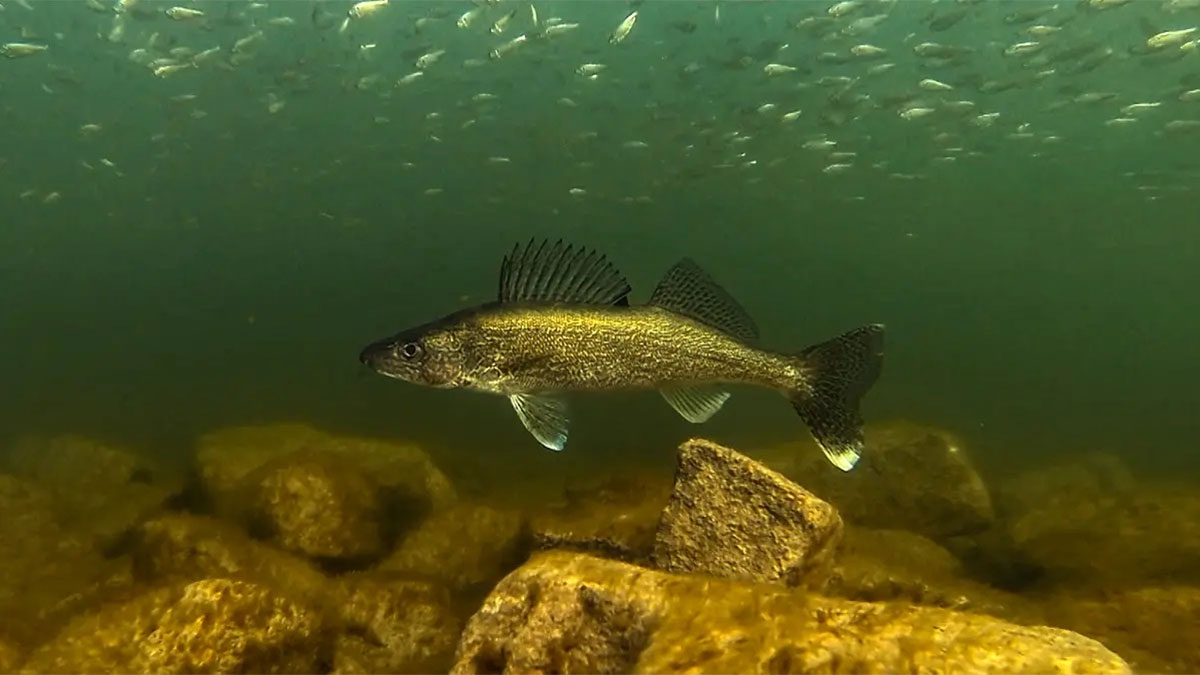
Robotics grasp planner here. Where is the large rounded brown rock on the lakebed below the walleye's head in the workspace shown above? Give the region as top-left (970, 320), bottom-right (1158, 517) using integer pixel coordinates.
top-left (196, 424), bottom-right (456, 558)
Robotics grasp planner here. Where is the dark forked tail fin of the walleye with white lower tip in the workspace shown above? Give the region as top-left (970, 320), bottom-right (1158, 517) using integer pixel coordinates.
top-left (788, 323), bottom-right (883, 471)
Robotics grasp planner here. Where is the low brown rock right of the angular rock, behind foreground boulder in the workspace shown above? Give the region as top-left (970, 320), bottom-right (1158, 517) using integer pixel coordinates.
top-left (823, 527), bottom-right (1036, 623)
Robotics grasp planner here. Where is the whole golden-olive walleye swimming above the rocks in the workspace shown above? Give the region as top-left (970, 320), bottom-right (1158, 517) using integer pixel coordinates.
top-left (359, 240), bottom-right (883, 471)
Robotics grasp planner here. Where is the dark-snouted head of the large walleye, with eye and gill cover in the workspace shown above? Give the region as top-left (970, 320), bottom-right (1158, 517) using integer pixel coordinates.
top-left (359, 323), bottom-right (466, 388)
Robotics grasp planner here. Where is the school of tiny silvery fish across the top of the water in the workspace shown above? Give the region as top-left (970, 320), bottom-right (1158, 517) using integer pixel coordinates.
top-left (0, 0), bottom-right (1200, 210)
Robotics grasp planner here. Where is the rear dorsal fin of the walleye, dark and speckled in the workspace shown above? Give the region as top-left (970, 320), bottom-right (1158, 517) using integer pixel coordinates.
top-left (650, 258), bottom-right (758, 341)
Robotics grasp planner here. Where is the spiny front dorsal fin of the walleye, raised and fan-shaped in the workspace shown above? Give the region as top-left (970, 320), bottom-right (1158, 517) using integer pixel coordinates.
top-left (499, 239), bottom-right (631, 305)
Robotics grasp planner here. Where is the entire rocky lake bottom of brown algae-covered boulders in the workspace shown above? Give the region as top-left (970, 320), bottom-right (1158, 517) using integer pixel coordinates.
top-left (0, 422), bottom-right (1200, 673)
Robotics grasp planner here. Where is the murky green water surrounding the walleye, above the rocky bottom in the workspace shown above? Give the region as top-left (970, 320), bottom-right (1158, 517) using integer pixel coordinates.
top-left (0, 0), bottom-right (1200, 480)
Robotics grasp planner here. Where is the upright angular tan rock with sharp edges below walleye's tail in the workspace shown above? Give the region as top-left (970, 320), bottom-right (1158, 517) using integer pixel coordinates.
top-left (654, 440), bottom-right (842, 586)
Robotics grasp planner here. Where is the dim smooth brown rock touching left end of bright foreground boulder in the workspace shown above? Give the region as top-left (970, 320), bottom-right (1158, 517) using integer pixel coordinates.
top-left (377, 502), bottom-right (527, 591)
